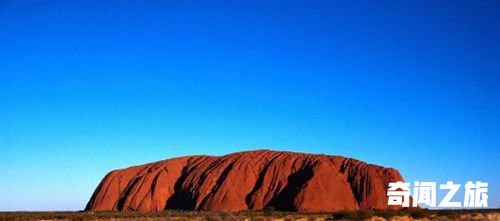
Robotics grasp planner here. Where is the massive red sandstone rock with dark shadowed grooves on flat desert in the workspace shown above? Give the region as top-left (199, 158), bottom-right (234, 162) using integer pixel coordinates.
top-left (85, 150), bottom-right (403, 212)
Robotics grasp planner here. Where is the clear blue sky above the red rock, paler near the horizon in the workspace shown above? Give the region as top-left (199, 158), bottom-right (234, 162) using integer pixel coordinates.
top-left (0, 0), bottom-right (500, 210)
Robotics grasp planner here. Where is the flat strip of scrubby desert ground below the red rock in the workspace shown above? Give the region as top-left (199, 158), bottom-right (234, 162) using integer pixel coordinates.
top-left (0, 209), bottom-right (500, 221)
